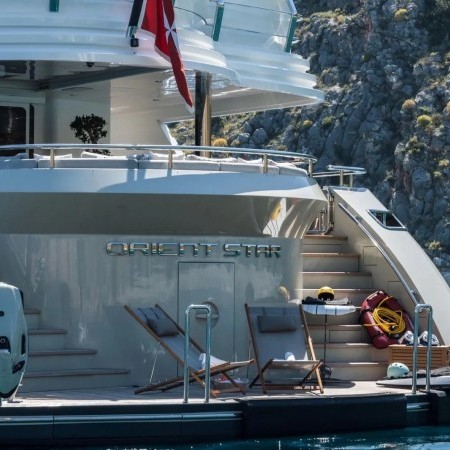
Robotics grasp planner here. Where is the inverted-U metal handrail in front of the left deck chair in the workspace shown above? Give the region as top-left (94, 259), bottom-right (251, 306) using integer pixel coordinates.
top-left (183, 305), bottom-right (211, 403)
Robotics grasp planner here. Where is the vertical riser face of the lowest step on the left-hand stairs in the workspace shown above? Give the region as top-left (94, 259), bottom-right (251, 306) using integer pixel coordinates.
top-left (18, 372), bottom-right (130, 398)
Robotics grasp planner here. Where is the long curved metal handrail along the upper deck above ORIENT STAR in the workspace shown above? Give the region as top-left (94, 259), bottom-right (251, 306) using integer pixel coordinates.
top-left (0, 144), bottom-right (317, 176)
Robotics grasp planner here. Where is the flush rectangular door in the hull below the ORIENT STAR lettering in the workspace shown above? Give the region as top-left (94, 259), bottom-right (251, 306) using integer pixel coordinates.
top-left (178, 262), bottom-right (236, 361)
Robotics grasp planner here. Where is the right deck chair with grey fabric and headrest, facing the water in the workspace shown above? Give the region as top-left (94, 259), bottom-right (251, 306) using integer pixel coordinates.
top-left (245, 304), bottom-right (323, 394)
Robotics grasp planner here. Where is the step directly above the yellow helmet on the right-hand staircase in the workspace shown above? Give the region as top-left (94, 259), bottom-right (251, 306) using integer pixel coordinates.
top-left (302, 272), bottom-right (372, 290)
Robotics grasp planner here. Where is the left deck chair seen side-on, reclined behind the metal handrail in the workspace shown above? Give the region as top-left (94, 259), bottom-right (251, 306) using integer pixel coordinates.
top-left (124, 305), bottom-right (254, 397)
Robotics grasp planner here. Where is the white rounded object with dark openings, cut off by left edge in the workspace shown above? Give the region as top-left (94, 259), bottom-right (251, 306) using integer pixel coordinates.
top-left (0, 282), bottom-right (28, 398)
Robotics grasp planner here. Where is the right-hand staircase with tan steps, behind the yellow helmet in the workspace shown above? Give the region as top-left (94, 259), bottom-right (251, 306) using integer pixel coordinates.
top-left (296, 235), bottom-right (389, 381)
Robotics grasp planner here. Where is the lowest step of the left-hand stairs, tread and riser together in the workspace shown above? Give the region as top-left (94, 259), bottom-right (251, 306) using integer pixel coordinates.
top-left (19, 368), bottom-right (130, 396)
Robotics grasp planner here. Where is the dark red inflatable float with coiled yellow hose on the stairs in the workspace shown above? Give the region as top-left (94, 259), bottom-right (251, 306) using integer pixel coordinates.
top-left (360, 291), bottom-right (414, 348)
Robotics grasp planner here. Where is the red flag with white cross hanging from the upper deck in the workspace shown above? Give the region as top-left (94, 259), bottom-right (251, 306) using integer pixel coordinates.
top-left (141, 0), bottom-right (193, 109)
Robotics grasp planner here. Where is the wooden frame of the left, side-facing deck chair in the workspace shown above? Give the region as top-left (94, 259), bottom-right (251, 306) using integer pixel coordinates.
top-left (124, 305), bottom-right (254, 397)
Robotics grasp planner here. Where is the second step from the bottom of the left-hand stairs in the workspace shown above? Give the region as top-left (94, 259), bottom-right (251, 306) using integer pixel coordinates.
top-left (27, 349), bottom-right (97, 372)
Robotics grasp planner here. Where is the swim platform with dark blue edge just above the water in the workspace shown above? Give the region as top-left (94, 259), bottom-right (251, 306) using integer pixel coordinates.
top-left (0, 381), bottom-right (450, 447)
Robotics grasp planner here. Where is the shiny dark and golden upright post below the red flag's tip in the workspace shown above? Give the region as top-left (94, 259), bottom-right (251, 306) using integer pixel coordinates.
top-left (195, 72), bottom-right (211, 157)
